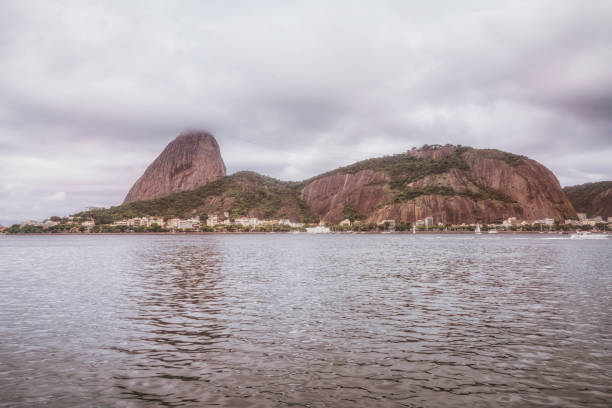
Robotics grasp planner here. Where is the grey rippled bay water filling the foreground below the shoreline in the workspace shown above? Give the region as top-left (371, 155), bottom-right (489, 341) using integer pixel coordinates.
top-left (0, 234), bottom-right (612, 407)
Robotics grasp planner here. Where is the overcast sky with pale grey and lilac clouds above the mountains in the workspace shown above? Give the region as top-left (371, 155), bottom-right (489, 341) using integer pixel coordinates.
top-left (0, 0), bottom-right (612, 226)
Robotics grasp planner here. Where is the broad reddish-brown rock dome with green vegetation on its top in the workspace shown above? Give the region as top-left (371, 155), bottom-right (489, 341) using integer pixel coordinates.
top-left (301, 145), bottom-right (575, 223)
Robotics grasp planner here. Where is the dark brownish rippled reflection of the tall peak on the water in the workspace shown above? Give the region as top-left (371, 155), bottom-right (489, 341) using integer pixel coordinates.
top-left (112, 240), bottom-right (230, 406)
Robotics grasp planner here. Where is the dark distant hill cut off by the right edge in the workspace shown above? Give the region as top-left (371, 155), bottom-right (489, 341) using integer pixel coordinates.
top-left (563, 181), bottom-right (612, 218)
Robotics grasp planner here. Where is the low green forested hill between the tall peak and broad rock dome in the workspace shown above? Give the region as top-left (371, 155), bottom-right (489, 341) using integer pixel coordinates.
top-left (75, 171), bottom-right (315, 223)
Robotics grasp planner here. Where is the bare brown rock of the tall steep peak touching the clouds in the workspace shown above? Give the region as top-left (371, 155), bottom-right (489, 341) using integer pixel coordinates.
top-left (123, 131), bottom-right (226, 204)
